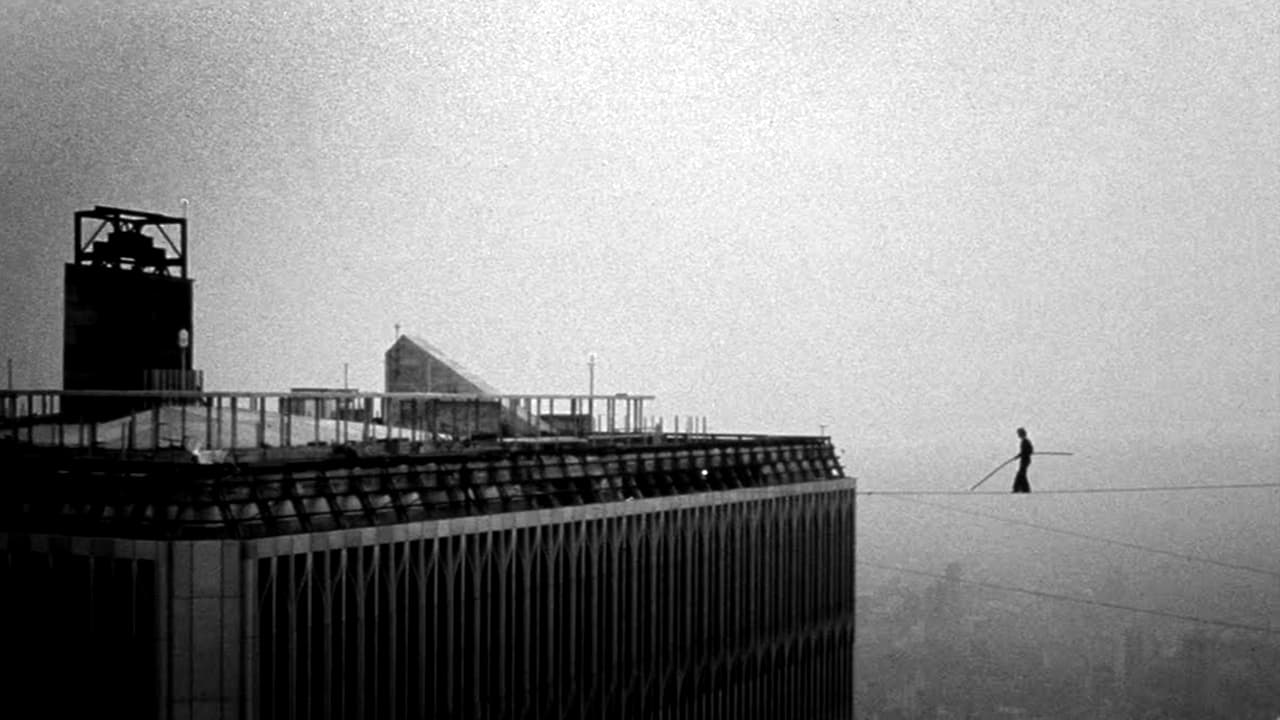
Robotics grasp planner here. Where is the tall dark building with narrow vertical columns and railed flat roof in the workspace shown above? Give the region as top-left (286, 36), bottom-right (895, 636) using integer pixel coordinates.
top-left (0, 204), bottom-right (856, 720)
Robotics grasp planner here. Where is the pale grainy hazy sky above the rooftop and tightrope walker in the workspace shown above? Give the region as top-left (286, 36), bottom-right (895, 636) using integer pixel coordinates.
top-left (0, 0), bottom-right (1280, 484)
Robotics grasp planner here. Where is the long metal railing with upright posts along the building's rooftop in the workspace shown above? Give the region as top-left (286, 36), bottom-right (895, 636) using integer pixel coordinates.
top-left (0, 389), bottom-right (707, 456)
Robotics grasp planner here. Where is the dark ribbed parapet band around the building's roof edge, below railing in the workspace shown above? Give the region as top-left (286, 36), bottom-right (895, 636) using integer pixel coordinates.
top-left (0, 436), bottom-right (844, 539)
